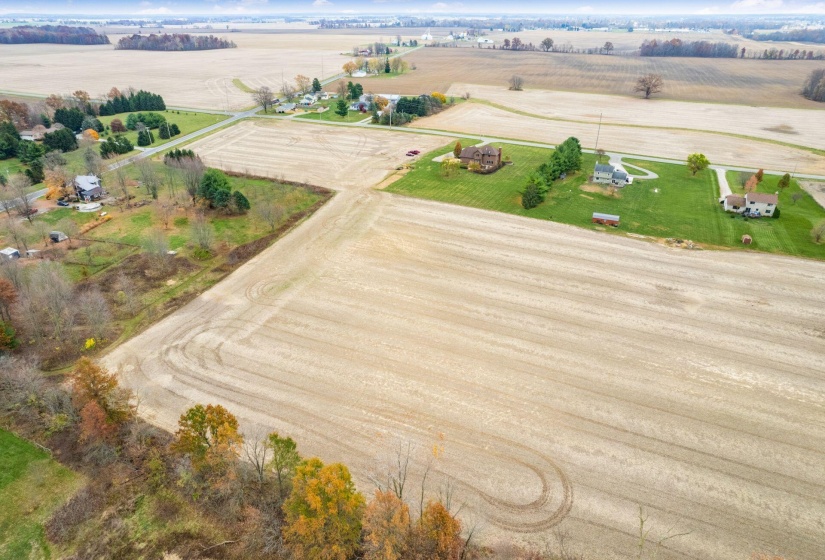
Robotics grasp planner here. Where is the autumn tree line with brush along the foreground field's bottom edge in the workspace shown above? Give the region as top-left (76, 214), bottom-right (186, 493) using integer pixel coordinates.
top-left (0, 354), bottom-right (482, 560)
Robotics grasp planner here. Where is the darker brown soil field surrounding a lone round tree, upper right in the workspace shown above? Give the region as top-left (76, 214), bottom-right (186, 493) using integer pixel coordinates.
top-left (370, 48), bottom-right (822, 109)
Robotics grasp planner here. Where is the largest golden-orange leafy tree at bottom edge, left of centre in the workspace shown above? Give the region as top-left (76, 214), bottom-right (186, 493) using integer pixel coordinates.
top-left (283, 458), bottom-right (364, 560)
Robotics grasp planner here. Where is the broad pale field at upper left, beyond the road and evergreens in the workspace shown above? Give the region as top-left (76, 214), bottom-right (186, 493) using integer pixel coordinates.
top-left (0, 33), bottom-right (377, 110)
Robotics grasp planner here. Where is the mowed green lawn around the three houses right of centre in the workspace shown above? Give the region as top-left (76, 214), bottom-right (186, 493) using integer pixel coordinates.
top-left (386, 144), bottom-right (825, 259)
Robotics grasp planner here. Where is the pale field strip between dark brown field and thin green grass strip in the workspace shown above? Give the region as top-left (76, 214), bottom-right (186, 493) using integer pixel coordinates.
top-left (448, 84), bottom-right (825, 150)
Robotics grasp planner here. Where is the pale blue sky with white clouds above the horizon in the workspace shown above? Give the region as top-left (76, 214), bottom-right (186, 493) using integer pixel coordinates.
top-left (0, 0), bottom-right (825, 15)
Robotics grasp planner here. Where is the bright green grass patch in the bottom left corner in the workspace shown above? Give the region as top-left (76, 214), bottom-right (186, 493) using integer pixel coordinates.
top-left (0, 430), bottom-right (82, 560)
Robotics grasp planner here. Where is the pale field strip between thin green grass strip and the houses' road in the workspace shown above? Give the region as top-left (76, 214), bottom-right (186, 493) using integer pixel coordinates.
top-left (408, 103), bottom-right (825, 175)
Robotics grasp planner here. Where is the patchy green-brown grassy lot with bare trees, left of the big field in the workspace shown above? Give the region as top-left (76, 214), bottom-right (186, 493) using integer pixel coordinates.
top-left (0, 158), bottom-right (331, 370)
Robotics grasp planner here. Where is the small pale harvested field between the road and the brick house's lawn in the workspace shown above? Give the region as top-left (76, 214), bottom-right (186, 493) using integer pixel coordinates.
top-left (189, 119), bottom-right (446, 188)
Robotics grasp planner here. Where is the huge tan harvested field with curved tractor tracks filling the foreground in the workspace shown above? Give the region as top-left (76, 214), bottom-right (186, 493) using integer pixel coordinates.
top-left (104, 161), bottom-right (825, 560)
